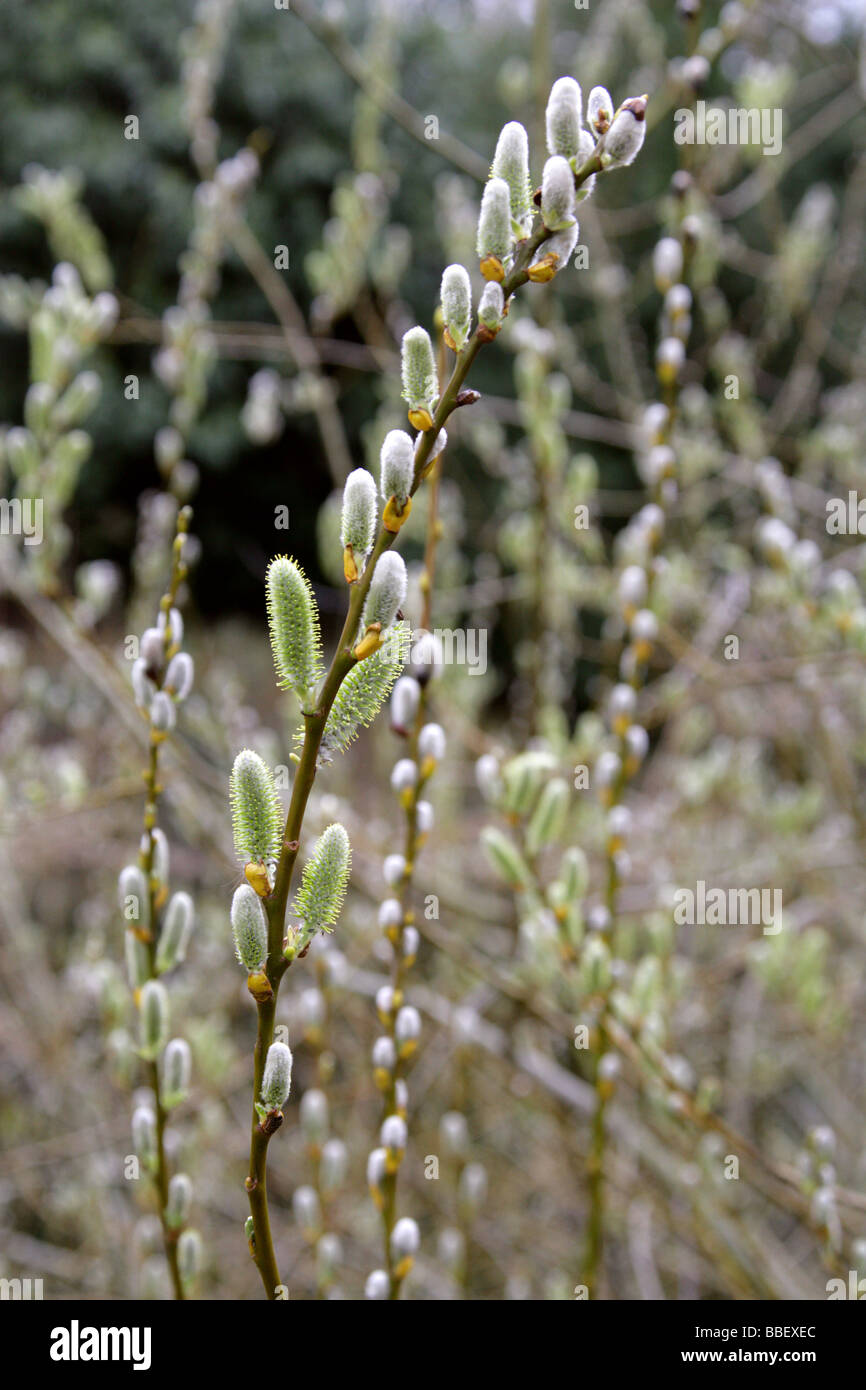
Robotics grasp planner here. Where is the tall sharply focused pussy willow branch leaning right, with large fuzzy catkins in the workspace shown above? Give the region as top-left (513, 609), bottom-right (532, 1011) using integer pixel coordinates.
top-left (232, 78), bottom-right (646, 1298)
